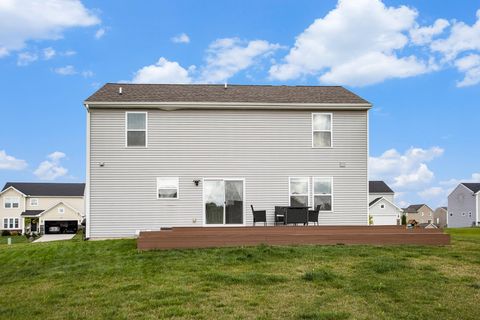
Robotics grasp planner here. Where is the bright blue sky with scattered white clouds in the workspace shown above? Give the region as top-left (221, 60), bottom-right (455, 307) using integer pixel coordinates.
top-left (0, 0), bottom-right (480, 207)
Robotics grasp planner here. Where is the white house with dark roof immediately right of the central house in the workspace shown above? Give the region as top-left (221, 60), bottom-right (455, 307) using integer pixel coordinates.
top-left (368, 181), bottom-right (402, 225)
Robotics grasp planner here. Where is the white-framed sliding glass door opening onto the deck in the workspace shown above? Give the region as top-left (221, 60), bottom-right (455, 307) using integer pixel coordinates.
top-left (203, 179), bottom-right (244, 225)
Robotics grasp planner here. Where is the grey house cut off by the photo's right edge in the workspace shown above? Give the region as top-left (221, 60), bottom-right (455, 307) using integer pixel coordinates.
top-left (447, 182), bottom-right (480, 228)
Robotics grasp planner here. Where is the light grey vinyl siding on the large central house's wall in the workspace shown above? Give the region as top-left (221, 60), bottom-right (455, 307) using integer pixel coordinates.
top-left (89, 109), bottom-right (368, 237)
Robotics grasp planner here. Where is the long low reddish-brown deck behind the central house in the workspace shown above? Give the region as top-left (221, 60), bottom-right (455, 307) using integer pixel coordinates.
top-left (137, 226), bottom-right (450, 250)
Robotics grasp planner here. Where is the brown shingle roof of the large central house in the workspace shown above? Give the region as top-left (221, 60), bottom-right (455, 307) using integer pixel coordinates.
top-left (85, 83), bottom-right (370, 104)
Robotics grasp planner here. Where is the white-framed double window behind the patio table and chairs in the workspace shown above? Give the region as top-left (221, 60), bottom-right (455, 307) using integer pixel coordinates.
top-left (289, 177), bottom-right (333, 212)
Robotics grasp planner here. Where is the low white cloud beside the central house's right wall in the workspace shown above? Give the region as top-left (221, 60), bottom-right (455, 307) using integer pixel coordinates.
top-left (369, 147), bottom-right (444, 188)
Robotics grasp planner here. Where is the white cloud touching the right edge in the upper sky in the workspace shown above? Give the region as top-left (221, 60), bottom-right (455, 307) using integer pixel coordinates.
top-left (430, 9), bottom-right (480, 60)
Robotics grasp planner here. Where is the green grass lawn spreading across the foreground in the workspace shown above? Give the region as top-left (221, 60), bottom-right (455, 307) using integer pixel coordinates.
top-left (0, 229), bottom-right (480, 319)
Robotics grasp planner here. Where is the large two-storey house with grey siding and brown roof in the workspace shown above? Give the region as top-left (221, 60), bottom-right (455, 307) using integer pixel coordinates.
top-left (84, 84), bottom-right (371, 238)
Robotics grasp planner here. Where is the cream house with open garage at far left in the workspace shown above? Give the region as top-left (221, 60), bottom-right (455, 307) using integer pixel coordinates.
top-left (0, 182), bottom-right (85, 233)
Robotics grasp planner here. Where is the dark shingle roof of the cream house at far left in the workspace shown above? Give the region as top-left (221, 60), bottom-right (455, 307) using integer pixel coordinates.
top-left (2, 182), bottom-right (85, 197)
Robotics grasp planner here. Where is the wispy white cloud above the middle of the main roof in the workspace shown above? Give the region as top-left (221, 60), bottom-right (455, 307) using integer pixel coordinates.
top-left (199, 38), bottom-right (281, 83)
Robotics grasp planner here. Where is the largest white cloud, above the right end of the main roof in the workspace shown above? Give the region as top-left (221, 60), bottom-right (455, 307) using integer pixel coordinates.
top-left (270, 0), bottom-right (430, 86)
